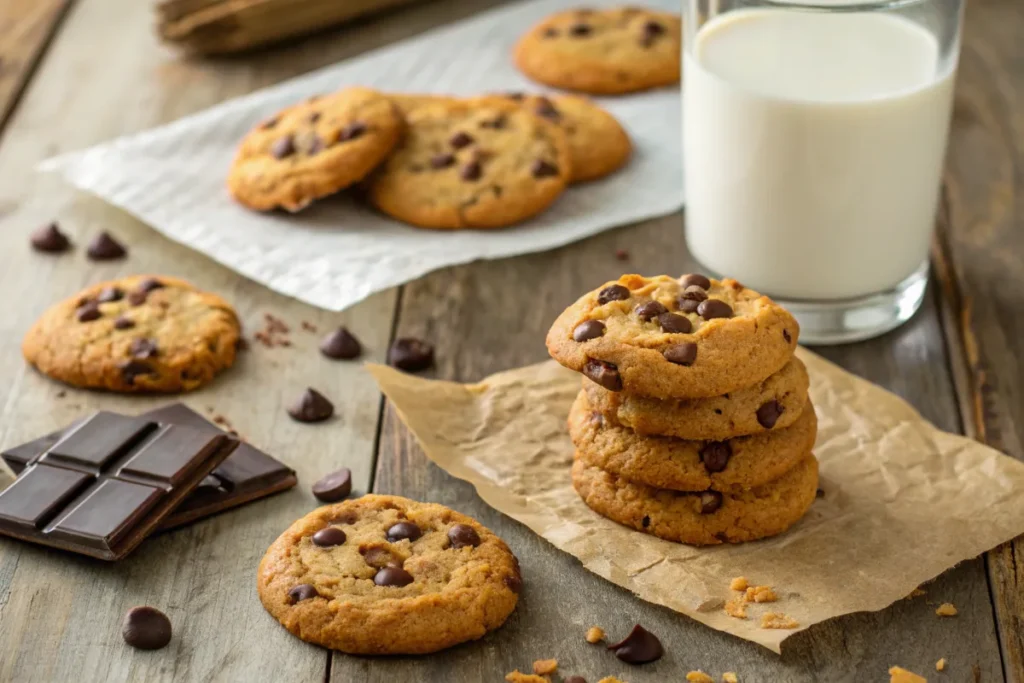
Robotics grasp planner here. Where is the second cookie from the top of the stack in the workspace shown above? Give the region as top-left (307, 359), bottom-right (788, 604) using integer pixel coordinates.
top-left (583, 356), bottom-right (810, 440)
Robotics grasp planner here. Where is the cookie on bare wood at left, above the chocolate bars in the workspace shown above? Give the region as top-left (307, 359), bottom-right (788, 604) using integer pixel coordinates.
top-left (22, 275), bottom-right (241, 392)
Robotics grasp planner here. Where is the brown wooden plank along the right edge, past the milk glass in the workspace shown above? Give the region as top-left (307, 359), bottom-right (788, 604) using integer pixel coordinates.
top-left (937, 0), bottom-right (1024, 682)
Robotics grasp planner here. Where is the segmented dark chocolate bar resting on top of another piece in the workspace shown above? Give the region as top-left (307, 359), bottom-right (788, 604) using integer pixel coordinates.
top-left (0, 411), bottom-right (240, 560)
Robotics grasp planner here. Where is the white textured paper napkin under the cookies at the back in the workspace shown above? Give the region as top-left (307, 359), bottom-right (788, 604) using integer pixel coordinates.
top-left (41, 0), bottom-right (683, 310)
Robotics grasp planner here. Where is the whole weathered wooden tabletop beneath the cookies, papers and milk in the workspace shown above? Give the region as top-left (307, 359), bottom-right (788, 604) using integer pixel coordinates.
top-left (0, 0), bottom-right (1024, 683)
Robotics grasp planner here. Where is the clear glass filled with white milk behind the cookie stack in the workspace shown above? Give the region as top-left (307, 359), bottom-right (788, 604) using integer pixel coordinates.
top-left (683, 0), bottom-right (964, 344)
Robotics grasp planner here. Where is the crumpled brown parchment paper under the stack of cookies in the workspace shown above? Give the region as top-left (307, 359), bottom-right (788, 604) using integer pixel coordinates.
top-left (368, 349), bottom-right (1024, 652)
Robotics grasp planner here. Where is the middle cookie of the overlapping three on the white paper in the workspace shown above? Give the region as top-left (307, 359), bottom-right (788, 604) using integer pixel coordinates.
top-left (368, 100), bottom-right (572, 229)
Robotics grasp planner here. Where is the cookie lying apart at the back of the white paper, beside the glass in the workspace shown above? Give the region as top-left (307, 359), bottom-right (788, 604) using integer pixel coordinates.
top-left (514, 7), bottom-right (682, 94)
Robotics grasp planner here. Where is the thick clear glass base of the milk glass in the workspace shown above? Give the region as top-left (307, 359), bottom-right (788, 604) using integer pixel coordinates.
top-left (769, 261), bottom-right (928, 345)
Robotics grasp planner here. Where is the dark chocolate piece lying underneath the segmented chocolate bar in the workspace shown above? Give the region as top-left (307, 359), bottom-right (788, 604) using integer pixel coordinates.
top-left (0, 403), bottom-right (298, 529)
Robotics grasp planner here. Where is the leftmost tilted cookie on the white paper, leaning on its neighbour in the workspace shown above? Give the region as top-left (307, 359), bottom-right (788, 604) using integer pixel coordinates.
top-left (227, 88), bottom-right (403, 211)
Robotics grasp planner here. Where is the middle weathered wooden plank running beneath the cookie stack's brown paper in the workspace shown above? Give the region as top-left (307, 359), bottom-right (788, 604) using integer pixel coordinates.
top-left (332, 216), bottom-right (1002, 683)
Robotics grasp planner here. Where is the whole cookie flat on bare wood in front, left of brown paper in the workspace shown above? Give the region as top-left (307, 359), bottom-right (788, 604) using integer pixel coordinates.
top-left (257, 495), bottom-right (522, 654)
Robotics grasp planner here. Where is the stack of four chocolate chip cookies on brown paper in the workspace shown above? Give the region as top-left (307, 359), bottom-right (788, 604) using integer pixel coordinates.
top-left (547, 274), bottom-right (818, 545)
